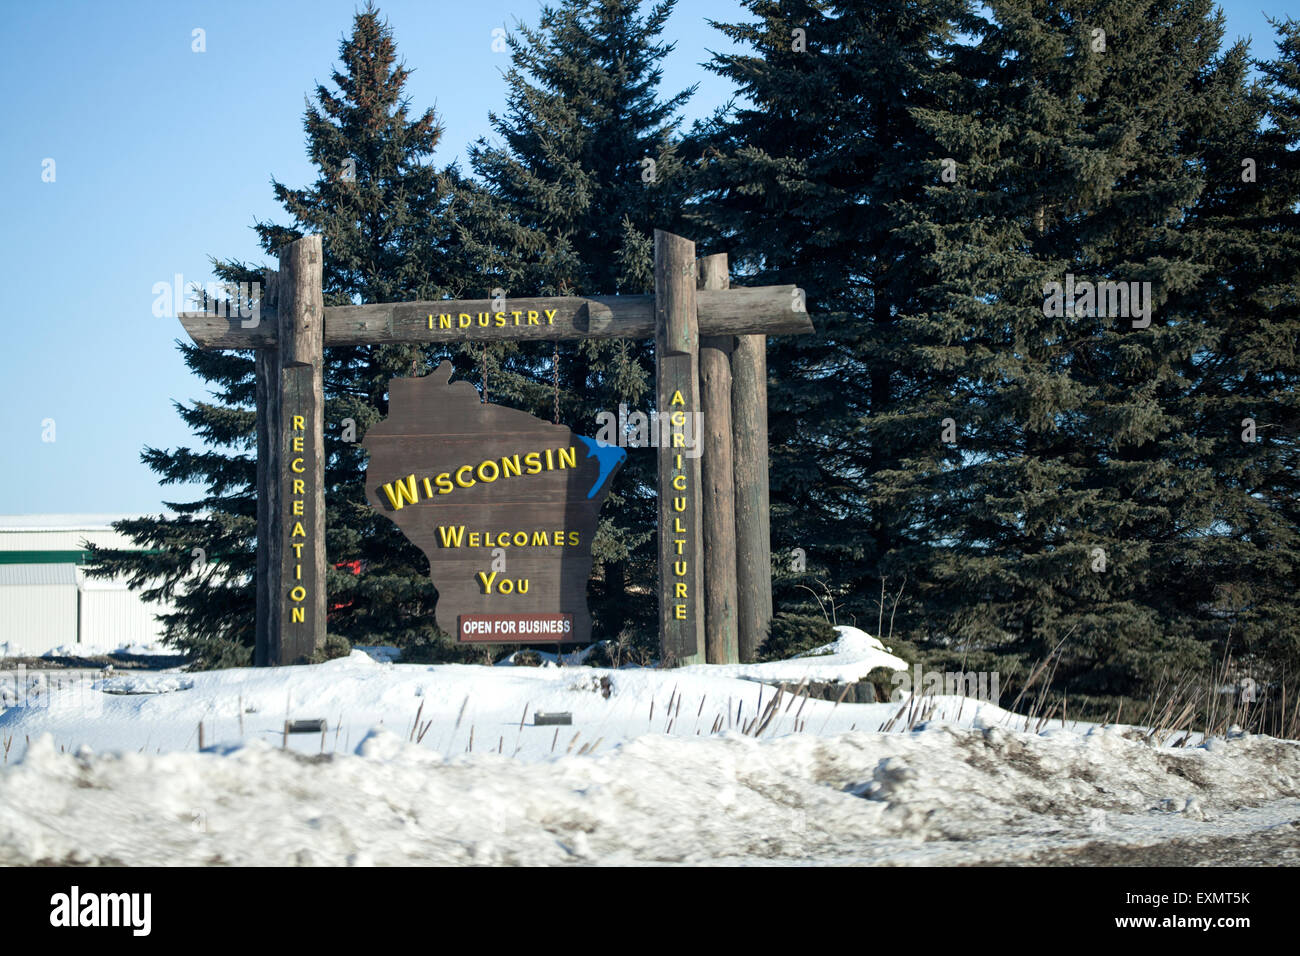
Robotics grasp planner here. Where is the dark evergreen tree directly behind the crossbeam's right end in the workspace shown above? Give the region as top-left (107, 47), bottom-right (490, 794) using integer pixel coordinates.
top-left (696, 0), bottom-right (970, 647)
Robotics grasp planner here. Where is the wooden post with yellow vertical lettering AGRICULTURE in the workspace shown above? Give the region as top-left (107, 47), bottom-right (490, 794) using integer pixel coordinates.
top-left (654, 229), bottom-right (705, 665)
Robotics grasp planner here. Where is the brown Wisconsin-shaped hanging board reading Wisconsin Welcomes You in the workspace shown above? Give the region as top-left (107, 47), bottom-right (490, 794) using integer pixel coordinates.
top-left (363, 362), bottom-right (627, 644)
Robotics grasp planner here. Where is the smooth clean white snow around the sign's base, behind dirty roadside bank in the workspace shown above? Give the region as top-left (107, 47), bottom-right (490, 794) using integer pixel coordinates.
top-left (0, 642), bottom-right (1013, 761)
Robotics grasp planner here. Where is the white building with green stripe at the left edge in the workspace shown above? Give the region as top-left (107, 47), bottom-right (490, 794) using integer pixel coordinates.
top-left (0, 515), bottom-right (170, 657)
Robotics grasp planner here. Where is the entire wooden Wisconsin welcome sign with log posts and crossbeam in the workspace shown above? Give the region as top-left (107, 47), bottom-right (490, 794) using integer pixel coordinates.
top-left (181, 230), bottom-right (813, 665)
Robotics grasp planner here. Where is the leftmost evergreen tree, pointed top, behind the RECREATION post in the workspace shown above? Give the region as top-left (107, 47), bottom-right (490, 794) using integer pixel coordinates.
top-left (92, 5), bottom-right (478, 666)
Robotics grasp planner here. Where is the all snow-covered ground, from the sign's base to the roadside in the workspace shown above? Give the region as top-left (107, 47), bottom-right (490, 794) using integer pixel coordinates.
top-left (0, 635), bottom-right (1300, 865)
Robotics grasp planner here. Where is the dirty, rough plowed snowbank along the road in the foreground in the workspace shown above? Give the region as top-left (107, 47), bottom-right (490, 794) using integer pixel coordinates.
top-left (0, 723), bottom-right (1300, 866)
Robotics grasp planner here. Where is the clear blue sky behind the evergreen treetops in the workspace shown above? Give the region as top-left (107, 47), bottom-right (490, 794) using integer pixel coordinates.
top-left (0, 0), bottom-right (1284, 514)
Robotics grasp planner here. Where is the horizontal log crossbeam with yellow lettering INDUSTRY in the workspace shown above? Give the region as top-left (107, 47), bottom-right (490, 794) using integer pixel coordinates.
top-left (179, 285), bottom-right (813, 349)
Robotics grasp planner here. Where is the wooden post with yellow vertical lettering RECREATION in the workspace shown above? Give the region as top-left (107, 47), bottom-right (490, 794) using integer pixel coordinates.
top-left (267, 235), bottom-right (325, 665)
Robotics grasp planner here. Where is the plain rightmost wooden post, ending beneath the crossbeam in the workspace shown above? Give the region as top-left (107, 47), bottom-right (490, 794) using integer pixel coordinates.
top-left (732, 336), bottom-right (772, 663)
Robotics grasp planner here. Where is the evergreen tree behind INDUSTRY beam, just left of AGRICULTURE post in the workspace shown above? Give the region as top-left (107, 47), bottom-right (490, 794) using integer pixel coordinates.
top-left (458, 0), bottom-right (692, 649)
